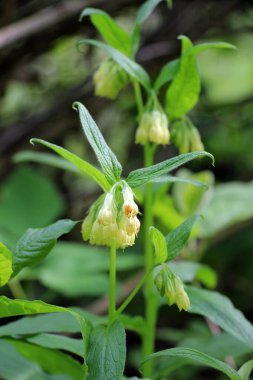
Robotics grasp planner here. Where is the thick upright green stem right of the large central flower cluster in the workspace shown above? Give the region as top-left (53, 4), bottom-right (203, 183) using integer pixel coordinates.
top-left (142, 144), bottom-right (157, 377)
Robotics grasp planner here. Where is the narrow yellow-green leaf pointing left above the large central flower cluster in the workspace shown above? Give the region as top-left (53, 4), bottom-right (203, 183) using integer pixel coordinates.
top-left (31, 139), bottom-right (110, 191)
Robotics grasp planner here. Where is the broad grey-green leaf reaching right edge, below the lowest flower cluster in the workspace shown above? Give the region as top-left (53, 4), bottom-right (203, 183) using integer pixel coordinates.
top-left (186, 286), bottom-right (253, 348)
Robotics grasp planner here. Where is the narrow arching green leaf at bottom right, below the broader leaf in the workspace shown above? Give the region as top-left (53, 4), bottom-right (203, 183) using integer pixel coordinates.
top-left (142, 347), bottom-right (241, 380)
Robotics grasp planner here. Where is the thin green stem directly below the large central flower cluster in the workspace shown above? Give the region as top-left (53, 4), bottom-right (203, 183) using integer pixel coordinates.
top-left (108, 239), bottom-right (117, 325)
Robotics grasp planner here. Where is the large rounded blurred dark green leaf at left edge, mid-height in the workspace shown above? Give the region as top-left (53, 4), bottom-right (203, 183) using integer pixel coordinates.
top-left (0, 167), bottom-right (64, 249)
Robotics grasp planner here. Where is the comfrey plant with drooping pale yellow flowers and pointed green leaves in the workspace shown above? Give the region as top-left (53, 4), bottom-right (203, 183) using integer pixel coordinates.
top-left (0, 0), bottom-right (253, 380)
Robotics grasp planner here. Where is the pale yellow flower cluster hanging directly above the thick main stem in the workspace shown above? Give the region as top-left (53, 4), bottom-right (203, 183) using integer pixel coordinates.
top-left (135, 110), bottom-right (170, 145)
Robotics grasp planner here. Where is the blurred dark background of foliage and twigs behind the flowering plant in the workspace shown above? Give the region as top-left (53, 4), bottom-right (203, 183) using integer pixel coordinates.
top-left (0, 0), bottom-right (253, 380)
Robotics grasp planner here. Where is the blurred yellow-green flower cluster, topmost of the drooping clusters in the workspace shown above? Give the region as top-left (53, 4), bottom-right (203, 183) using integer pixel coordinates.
top-left (93, 58), bottom-right (128, 99)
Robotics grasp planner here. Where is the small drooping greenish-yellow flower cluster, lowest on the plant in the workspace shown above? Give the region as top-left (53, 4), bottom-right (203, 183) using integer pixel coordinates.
top-left (154, 264), bottom-right (190, 311)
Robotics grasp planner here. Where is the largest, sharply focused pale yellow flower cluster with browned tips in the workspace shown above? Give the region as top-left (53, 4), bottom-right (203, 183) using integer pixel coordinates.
top-left (82, 181), bottom-right (140, 248)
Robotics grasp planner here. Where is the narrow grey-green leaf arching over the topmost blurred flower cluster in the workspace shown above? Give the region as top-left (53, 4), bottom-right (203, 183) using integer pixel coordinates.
top-left (79, 39), bottom-right (151, 91)
